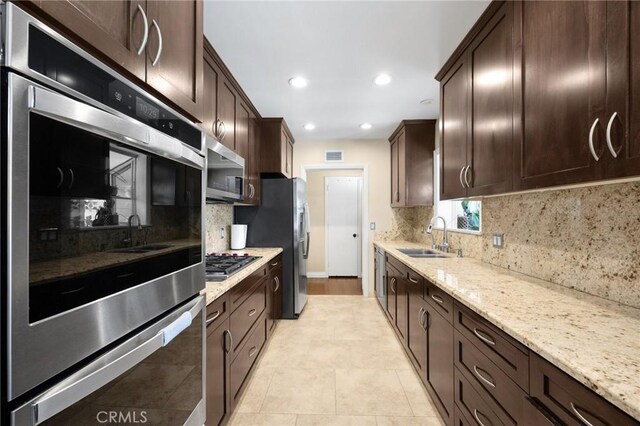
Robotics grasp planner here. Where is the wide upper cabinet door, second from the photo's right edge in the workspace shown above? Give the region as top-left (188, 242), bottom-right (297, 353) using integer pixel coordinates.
top-left (514, 1), bottom-right (607, 190)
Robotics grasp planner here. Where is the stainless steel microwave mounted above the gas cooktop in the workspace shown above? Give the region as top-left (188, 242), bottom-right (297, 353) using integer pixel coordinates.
top-left (205, 137), bottom-right (244, 203)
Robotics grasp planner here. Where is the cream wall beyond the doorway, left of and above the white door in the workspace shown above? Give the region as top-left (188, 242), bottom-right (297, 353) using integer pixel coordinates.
top-left (307, 170), bottom-right (362, 275)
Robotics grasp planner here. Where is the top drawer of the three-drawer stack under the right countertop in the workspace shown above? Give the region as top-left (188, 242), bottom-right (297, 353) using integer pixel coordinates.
top-left (454, 303), bottom-right (529, 391)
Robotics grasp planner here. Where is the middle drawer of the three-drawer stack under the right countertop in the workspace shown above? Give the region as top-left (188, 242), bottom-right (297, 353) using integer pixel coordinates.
top-left (454, 330), bottom-right (526, 424)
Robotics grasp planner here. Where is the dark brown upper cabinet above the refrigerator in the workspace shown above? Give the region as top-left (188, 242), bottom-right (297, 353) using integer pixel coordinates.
top-left (260, 118), bottom-right (295, 178)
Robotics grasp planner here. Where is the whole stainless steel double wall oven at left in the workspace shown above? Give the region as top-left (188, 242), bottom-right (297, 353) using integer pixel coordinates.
top-left (0, 3), bottom-right (205, 425)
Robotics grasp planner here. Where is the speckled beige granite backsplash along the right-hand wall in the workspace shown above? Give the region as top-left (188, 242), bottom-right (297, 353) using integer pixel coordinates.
top-left (376, 182), bottom-right (640, 308)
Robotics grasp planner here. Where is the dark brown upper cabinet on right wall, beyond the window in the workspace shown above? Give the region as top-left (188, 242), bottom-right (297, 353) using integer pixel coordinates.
top-left (389, 120), bottom-right (436, 207)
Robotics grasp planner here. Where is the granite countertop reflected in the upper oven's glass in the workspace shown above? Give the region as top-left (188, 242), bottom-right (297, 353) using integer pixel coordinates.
top-left (29, 239), bottom-right (202, 284)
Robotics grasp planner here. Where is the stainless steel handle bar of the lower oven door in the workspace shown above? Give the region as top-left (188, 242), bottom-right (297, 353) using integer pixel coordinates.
top-left (26, 296), bottom-right (205, 425)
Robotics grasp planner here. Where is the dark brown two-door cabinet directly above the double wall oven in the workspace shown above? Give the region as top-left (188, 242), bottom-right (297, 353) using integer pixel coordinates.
top-left (21, 0), bottom-right (203, 121)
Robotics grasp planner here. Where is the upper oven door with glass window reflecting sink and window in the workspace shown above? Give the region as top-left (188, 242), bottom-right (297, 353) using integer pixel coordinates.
top-left (2, 73), bottom-right (204, 400)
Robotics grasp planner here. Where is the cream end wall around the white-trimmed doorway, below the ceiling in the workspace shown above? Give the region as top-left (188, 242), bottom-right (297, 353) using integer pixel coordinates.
top-left (293, 139), bottom-right (392, 296)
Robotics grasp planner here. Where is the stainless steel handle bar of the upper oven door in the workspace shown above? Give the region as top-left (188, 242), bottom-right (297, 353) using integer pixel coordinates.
top-left (28, 85), bottom-right (204, 169)
